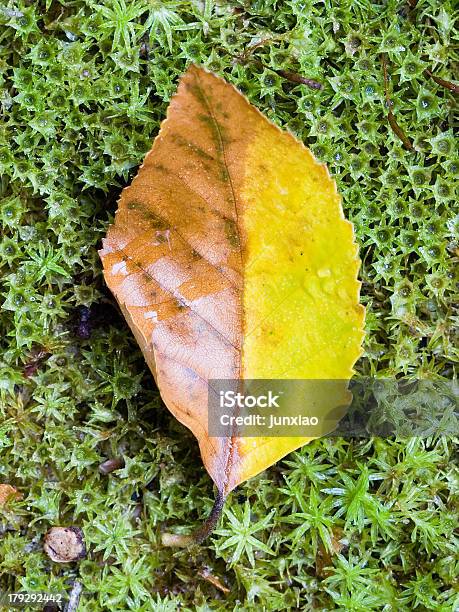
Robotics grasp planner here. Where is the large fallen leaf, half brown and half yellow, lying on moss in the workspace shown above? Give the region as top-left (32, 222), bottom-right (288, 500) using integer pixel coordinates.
top-left (100, 66), bottom-right (364, 540)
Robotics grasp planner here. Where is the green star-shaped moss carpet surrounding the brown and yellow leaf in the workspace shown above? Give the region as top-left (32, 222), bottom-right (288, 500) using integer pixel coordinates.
top-left (0, 0), bottom-right (459, 611)
